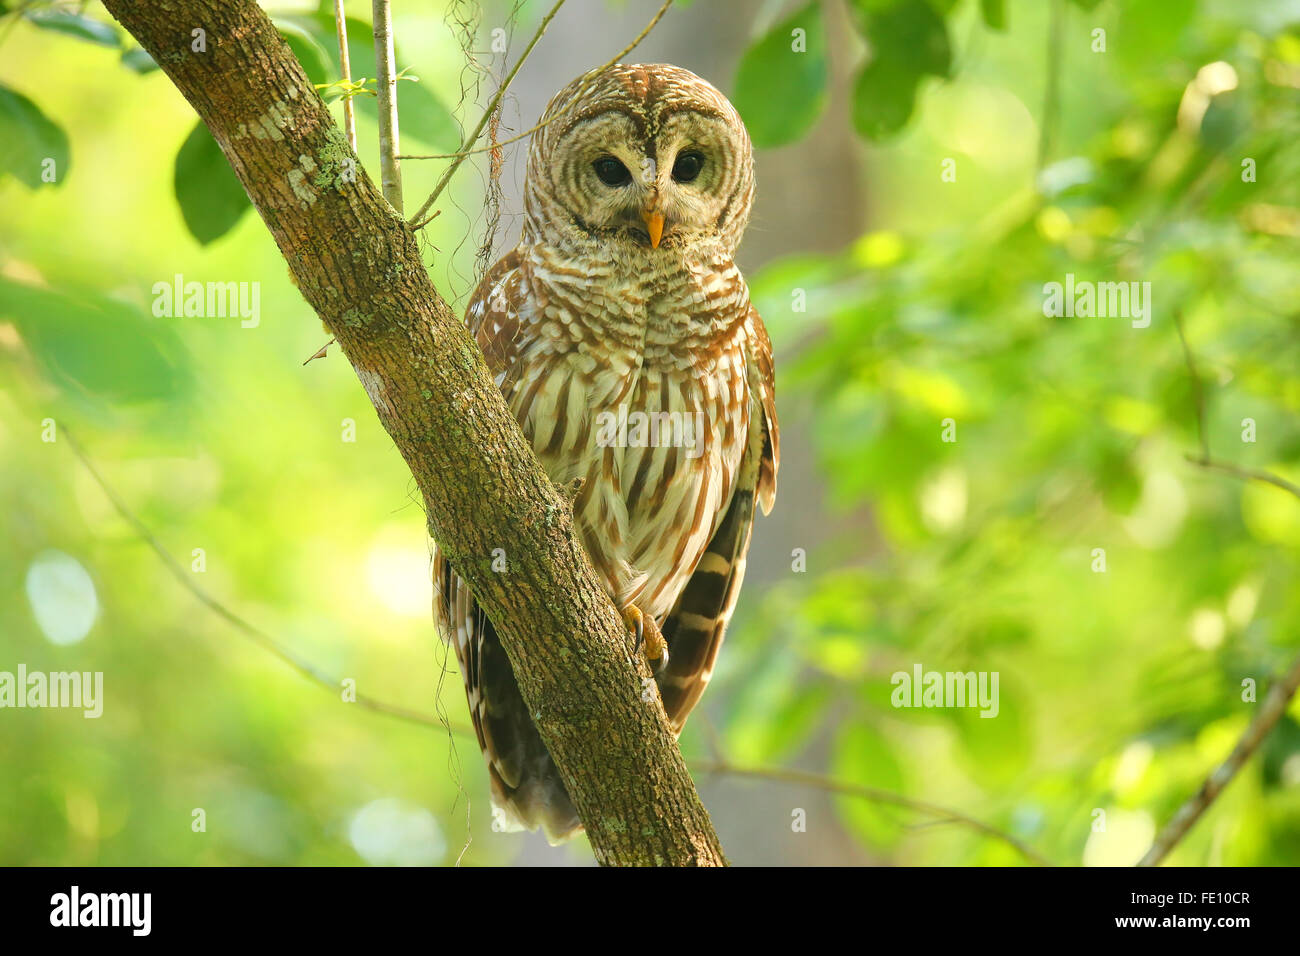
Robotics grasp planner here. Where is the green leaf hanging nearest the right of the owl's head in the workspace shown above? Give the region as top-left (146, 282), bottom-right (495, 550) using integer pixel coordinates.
top-left (732, 3), bottom-right (829, 147)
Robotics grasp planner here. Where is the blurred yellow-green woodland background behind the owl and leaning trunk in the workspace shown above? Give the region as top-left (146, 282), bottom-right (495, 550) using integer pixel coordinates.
top-left (0, 0), bottom-right (1300, 865)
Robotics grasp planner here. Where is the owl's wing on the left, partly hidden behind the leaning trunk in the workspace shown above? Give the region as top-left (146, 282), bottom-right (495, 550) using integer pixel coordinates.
top-left (433, 252), bottom-right (580, 843)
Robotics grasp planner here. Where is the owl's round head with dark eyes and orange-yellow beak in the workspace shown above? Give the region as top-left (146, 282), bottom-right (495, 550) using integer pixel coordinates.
top-left (524, 64), bottom-right (754, 255)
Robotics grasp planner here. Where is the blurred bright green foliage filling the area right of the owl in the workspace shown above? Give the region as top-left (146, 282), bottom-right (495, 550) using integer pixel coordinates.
top-left (722, 0), bottom-right (1300, 865)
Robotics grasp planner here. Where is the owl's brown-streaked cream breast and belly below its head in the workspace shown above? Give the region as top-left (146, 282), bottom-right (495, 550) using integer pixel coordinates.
top-left (469, 246), bottom-right (767, 619)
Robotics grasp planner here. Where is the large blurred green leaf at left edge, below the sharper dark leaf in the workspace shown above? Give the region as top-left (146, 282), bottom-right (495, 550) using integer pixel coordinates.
top-left (0, 277), bottom-right (190, 406)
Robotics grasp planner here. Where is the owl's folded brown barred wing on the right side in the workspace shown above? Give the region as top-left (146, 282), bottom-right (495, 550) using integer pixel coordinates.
top-left (659, 307), bottom-right (781, 734)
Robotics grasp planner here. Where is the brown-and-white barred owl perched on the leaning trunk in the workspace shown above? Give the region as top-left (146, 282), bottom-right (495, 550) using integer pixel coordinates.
top-left (433, 64), bottom-right (780, 843)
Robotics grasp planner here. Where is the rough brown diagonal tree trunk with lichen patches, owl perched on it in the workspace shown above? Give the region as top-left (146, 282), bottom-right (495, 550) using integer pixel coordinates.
top-left (104, 0), bottom-right (725, 865)
